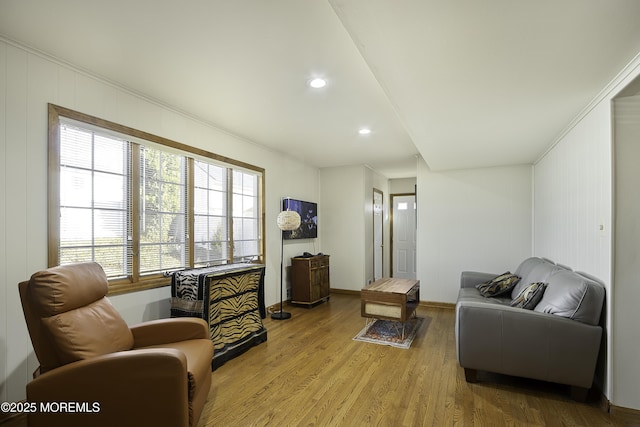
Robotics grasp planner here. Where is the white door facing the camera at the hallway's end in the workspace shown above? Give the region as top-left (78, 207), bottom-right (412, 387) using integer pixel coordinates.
top-left (391, 194), bottom-right (417, 279)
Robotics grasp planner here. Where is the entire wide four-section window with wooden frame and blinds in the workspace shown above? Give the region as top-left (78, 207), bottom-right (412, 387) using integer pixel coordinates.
top-left (49, 105), bottom-right (264, 293)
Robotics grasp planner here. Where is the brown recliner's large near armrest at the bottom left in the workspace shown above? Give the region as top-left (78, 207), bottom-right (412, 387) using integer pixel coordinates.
top-left (27, 349), bottom-right (189, 427)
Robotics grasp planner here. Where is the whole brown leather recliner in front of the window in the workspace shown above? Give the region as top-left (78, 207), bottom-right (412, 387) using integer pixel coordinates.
top-left (19, 263), bottom-right (213, 427)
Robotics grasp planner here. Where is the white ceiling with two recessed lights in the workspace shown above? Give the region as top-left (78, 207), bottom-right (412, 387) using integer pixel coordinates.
top-left (0, 0), bottom-right (640, 178)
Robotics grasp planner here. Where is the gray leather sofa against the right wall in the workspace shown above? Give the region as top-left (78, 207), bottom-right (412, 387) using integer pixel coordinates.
top-left (455, 257), bottom-right (605, 400)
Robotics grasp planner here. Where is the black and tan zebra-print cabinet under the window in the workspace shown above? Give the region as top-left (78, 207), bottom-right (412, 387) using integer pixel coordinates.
top-left (171, 263), bottom-right (267, 369)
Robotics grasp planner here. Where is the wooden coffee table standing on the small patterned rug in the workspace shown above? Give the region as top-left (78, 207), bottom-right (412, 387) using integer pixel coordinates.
top-left (360, 278), bottom-right (420, 339)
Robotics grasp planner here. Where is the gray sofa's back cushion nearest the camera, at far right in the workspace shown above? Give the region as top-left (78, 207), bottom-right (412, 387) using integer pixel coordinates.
top-left (534, 269), bottom-right (605, 325)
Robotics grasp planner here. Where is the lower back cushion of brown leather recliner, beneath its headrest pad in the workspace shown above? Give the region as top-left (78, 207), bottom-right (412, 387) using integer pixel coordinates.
top-left (42, 298), bottom-right (133, 364)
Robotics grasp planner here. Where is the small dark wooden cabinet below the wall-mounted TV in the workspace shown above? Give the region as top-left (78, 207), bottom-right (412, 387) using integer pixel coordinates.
top-left (291, 255), bottom-right (330, 306)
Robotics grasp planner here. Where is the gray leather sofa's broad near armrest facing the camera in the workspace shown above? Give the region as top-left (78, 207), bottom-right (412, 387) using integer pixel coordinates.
top-left (455, 301), bottom-right (602, 388)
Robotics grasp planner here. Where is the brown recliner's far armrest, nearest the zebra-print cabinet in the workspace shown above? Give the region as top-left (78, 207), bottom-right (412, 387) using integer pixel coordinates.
top-left (131, 317), bottom-right (210, 348)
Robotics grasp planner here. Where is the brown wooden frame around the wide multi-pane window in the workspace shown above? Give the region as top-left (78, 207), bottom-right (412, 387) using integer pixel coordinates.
top-left (47, 104), bottom-right (266, 295)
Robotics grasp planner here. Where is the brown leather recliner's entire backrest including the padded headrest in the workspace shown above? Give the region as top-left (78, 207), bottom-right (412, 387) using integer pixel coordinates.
top-left (19, 262), bottom-right (133, 373)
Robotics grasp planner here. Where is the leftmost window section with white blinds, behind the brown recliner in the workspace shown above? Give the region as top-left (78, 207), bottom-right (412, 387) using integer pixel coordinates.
top-left (58, 125), bottom-right (129, 277)
